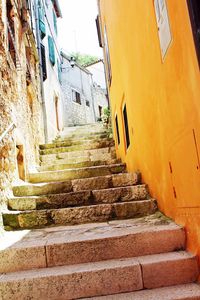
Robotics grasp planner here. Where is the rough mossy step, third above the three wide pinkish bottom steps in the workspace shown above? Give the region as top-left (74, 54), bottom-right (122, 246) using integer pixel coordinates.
top-left (13, 173), bottom-right (141, 197)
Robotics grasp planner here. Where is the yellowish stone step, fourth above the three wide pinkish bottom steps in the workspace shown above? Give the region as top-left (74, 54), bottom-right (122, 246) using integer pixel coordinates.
top-left (29, 164), bottom-right (126, 183)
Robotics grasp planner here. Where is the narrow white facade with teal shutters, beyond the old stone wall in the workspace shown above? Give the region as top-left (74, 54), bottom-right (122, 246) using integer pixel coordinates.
top-left (34, 0), bottom-right (63, 142)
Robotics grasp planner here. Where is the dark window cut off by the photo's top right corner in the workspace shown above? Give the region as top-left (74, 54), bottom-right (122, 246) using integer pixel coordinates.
top-left (188, 0), bottom-right (200, 65)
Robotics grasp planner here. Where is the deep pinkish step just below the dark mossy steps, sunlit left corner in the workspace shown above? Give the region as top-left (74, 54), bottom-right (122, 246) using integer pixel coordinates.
top-left (0, 217), bottom-right (185, 273)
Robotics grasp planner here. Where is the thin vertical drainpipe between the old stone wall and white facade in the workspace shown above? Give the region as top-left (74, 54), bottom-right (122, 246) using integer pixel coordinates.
top-left (34, 0), bottom-right (48, 143)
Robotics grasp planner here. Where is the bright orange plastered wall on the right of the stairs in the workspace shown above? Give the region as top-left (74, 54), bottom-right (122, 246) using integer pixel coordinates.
top-left (99, 0), bottom-right (200, 255)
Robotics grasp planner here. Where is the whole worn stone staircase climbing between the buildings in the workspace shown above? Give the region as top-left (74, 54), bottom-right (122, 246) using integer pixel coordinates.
top-left (0, 124), bottom-right (200, 300)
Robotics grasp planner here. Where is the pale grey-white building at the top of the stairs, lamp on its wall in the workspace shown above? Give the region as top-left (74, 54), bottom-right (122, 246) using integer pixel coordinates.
top-left (61, 53), bottom-right (107, 126)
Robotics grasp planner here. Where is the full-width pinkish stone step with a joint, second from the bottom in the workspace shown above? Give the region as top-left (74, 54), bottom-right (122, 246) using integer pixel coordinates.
top-left (0, 252), bottom-right (198, 300)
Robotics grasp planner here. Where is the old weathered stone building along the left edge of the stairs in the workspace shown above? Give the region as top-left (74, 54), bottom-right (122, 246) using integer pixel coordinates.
top-left (0, 0), bottom-right (43, 230)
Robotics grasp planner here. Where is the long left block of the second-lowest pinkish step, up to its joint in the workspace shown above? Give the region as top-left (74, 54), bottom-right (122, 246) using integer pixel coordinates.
top-left (0, 259), bottom-right (142, 300)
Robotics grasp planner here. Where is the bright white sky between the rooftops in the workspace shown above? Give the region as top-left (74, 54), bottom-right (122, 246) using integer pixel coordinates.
top-left (58, 0), bottom-right (102, 57)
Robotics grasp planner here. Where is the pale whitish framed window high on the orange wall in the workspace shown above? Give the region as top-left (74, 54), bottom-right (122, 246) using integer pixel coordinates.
top-left (154, 0), bottom-right (172, 59)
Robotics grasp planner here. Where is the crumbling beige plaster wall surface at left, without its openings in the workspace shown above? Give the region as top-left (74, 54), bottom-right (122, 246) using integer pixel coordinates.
top-left (0, 0), bottom-right (44, 231)
